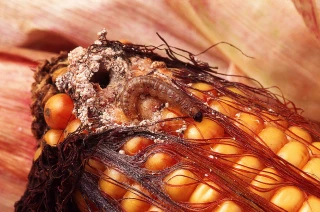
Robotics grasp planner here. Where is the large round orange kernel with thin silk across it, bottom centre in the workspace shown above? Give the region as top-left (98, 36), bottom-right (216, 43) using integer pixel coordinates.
top-left (164, 169), bottom-right (198, 201)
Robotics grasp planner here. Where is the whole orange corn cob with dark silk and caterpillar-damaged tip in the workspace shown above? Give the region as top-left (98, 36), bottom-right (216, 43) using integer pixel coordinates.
top-left (15, 32), bottom-right (320, 212)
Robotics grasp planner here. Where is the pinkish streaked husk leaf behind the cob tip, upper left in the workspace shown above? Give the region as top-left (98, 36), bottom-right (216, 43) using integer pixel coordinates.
top-left (0, 0), bottom-right (223, 64)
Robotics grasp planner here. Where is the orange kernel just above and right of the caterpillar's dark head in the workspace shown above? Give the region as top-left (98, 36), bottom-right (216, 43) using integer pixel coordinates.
top-left (209, 96), bottom-right (239, 117)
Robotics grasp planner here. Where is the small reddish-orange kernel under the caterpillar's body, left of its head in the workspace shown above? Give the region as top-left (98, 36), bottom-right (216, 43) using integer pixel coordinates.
top-left (161, 108), bottom-right (184, 133)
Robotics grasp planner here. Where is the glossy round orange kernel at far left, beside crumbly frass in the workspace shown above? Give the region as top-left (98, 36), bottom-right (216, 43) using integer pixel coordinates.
top-left (44, 93), bottom-right (75, 130)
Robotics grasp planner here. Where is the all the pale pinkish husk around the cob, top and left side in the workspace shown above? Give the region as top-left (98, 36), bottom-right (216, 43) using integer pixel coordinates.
top-left (0, 1), bottom-right (320, 211)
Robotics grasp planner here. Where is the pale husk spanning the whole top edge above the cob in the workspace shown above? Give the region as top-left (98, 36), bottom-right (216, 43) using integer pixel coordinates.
top-left (0, 0), bottom-right (320, 121)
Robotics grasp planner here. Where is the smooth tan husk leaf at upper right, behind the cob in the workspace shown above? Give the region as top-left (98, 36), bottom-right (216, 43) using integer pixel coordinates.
top-left (168, 0), bottom-right (320, 120)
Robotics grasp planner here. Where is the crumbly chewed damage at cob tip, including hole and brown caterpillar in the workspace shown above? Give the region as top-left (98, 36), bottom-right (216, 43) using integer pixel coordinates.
top-left (56, 31), bottom-right (202, 130)
